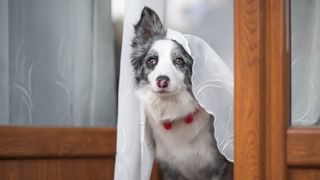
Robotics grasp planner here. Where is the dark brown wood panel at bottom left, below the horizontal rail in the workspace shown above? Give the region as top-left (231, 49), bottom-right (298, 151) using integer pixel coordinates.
top-left (0, 158), bottom-right (114, 180)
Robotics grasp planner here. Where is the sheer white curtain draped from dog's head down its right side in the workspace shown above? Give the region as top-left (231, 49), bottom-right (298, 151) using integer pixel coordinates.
top-left (167, 29), bottom-right (233, 161)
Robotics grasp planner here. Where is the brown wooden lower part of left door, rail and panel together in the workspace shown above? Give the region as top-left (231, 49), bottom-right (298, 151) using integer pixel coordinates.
top-left (0, 126), bottom-right (161, 180)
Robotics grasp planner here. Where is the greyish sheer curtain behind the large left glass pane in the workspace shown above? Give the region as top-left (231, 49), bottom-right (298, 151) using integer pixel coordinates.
top-left (0, 0), bottom-right (116, 126)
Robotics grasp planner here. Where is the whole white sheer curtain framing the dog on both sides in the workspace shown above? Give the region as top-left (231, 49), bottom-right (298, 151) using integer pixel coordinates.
top-left (115, 1), bottom-right (233, 180)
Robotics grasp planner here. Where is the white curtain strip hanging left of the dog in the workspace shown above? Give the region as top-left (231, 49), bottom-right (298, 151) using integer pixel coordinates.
top-left (114, 0), bottom-right (165, 180)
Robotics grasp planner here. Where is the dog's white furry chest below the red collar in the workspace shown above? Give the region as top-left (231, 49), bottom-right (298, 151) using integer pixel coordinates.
top-left (150, 110), bottom-right (215, 176)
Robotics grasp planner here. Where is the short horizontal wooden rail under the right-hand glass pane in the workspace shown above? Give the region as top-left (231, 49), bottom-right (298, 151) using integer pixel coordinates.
top-left (287, 127), bottom-right (320, 167)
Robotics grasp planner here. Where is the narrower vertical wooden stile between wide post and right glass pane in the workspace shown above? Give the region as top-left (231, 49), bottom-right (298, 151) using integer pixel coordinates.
top-left (265, 0), bottom-right (291, 180)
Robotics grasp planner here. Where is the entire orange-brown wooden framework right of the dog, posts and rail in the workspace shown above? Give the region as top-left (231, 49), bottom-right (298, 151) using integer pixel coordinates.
top-left (234, 0), bottom-right (320, 180)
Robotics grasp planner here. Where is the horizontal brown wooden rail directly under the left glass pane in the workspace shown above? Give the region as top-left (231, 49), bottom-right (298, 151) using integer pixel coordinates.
top-left (0, 126), bottom-right (116, 159)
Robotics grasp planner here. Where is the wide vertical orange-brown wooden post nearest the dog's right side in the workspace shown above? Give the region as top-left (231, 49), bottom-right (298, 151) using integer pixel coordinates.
top-left (234, 0), bottom-right (265, 180)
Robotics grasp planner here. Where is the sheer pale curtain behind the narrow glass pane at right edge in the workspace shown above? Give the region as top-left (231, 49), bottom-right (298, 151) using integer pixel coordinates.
top-left (291, 0), bottom-right (320, 126)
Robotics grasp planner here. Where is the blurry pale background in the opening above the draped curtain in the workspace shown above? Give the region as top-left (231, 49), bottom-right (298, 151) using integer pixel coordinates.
top-left (166, 0), bottom-right (234, 70)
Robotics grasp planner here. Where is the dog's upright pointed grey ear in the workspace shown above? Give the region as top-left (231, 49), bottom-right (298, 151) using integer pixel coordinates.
top-left (134, 7), bottom-right (166, 41)
